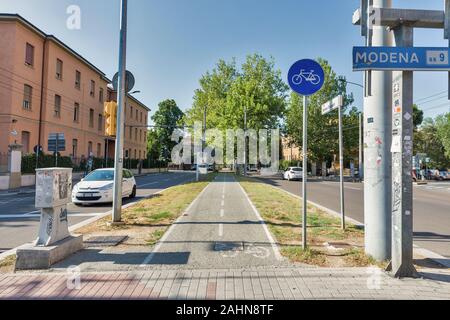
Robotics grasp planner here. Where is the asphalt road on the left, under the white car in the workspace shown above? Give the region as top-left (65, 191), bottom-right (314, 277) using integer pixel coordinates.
top-left (0, 172), bottom-right (195, 253)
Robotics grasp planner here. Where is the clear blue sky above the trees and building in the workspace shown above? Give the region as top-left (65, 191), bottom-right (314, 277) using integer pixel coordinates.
top-left (0, 0), bottom-right (450, 121)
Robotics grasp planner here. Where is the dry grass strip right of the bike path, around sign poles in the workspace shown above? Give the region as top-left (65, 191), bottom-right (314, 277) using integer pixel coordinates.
top-left (238, 177), bottom-right (376, 267)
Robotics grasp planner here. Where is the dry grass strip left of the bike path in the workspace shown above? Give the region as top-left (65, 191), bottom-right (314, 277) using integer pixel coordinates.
top-left (77, 174), bottom-right (216, 246)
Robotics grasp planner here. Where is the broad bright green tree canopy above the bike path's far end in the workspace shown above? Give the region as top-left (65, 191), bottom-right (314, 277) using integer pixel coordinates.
top-left (186, 54), bottom-right (288, 130)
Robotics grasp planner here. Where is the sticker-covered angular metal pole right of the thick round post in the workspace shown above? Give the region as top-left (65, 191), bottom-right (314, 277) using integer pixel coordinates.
top-left (390, 26), bottom-right (417, 278)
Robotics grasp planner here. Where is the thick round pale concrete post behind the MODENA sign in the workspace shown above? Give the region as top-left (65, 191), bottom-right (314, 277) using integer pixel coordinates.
top-left (364, 0), bottom-right (393, 261)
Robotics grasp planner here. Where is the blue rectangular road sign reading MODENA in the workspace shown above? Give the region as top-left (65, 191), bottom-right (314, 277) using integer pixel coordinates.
top-left (353, 47), bottom-right (450, 71)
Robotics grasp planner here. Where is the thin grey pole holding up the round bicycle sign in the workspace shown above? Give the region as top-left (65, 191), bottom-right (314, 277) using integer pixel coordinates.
top-left (302, 96), bottom-right (308, 250)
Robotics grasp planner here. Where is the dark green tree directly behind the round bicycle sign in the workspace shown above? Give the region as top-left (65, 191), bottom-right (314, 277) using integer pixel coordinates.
top-left (286, 59), bottom-right (359, 162)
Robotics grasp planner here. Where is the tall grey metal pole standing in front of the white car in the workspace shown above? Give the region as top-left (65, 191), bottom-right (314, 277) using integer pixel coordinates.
top-left (112, 0), bottom-right (128, 223)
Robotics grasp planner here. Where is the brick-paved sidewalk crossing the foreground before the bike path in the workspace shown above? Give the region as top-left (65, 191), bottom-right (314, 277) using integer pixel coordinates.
top-left (0, 268), bottom-right (450, 300)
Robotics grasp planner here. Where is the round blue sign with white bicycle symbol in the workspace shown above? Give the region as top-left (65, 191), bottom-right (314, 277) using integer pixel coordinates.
top-left (288, 59), bottom-right (325, 96)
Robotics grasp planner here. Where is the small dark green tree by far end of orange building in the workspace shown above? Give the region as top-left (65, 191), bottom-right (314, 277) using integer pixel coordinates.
top-left (149, 99), bottom-right (184, 161)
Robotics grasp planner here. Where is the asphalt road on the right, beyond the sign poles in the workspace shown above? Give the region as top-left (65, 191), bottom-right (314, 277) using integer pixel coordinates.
top-left (253, 177), bottom-right (450, 258)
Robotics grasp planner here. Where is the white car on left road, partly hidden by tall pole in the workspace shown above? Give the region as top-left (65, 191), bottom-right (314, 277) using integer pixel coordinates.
top-left (72, 169), bottom-right (136, 205)
